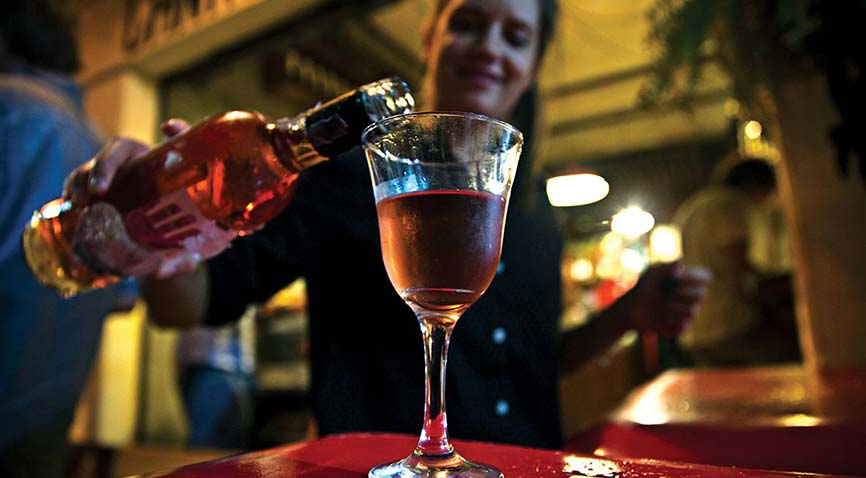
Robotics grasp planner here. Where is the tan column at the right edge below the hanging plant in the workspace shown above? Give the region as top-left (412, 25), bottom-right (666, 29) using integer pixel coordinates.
top-left (776, 77), bottom-right (866, 414)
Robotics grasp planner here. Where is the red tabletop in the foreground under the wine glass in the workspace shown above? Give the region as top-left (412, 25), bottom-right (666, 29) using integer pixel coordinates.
top-left (133, 433), bottom-right (852, 478)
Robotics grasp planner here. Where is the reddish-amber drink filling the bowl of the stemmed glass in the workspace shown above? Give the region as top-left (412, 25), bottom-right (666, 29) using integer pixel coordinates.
top-left (376, 190), bottom-right (505, 315)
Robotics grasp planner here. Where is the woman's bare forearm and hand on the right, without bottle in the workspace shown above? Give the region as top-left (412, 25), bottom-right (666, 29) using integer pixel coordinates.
top-left (559, 263), bottom-right (710, 374)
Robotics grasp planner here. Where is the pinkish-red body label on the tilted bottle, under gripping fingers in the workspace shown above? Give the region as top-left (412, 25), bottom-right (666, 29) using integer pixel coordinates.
top-left (73, 189), bottom-right (237, 276)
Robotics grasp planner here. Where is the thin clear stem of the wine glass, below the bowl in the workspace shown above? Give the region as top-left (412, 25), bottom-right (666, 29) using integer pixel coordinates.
top-left (415, 317), bottom-right (456, 456)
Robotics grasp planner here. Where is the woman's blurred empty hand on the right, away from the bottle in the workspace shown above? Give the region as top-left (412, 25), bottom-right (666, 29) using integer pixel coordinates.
top-left (624, 262), bottom-right (712, 336)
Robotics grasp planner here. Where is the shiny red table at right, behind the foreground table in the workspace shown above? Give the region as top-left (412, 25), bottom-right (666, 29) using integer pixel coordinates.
top-left (565, 366), bottom-right (866, 476)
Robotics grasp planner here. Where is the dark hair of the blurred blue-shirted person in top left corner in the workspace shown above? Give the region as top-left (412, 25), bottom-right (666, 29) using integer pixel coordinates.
top-left (0, 0), bottom-right (79, 74)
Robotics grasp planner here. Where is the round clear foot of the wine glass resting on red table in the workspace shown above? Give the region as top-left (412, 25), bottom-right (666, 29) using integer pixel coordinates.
top-left (367, 452), bottom-right (504, 478)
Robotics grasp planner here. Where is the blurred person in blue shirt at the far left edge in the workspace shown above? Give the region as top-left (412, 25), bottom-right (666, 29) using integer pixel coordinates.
top-left (0, 0), bottom-right (132, 478)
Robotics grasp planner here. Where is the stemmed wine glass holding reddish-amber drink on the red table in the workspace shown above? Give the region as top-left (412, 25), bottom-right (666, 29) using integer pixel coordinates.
top-left (363, 113), bottom-right (523, 478)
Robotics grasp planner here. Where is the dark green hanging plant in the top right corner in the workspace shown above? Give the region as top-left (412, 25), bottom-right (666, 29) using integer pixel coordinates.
top-left (641, 0), bottom-right (866, 182)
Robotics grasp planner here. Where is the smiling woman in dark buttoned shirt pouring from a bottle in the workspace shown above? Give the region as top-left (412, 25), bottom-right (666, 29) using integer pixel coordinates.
top-left (66, 0), bottom-right (705, 447)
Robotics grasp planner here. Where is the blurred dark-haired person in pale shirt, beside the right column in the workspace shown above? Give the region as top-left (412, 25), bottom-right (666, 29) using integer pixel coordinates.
top-left (674, 152), bottom-right (799, 366)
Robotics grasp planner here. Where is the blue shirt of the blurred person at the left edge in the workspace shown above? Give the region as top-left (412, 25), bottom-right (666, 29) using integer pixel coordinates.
top-left (0, 78), bottom-right (116, 456)
